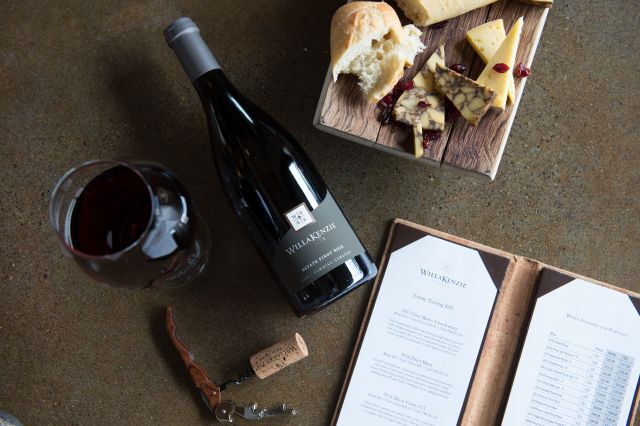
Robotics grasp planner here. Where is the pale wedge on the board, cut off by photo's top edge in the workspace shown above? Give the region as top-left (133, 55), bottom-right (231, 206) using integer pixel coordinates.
top-left (396, 0), bottom-right (497, 27)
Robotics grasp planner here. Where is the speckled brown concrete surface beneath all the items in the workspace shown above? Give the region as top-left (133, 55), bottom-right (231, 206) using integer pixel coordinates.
top-left (0, 0), bottom-right (640, 425)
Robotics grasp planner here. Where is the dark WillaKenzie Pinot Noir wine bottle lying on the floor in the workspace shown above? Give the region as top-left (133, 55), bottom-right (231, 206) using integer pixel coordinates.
top-left (164, 18), bottom-right (377, 317)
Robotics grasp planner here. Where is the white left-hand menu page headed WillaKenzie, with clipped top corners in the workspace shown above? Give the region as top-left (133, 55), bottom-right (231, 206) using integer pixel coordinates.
top-left (337, 236), bottom-right (497, 426)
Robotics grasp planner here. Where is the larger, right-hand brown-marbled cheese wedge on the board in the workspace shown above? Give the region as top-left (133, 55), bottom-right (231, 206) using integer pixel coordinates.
top-left (434, 65), bottom-right (496, 126)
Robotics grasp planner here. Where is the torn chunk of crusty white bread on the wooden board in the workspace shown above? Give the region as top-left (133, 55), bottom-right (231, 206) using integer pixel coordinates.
top-left (331, 1), bottom-right (424, 102)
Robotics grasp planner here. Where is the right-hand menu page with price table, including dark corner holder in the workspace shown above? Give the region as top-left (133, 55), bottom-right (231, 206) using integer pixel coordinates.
top-left (502, 270), bottom-right (640, 426)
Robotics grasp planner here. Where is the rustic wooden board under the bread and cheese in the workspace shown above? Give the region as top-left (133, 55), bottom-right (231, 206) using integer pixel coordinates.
top-left (314, 0), bottom-right (549, 180)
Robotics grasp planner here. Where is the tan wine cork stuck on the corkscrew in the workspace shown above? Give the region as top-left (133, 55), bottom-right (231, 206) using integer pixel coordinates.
top-left (249, 333), bottom-right (309, 379)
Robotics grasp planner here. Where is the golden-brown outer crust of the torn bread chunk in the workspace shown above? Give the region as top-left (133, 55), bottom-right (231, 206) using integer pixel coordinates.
top-left (330, 1), bottom-right (404, 70)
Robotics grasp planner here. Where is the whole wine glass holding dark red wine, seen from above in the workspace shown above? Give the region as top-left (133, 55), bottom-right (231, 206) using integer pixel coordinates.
top-left (49, 160), bottom-right (211, 288)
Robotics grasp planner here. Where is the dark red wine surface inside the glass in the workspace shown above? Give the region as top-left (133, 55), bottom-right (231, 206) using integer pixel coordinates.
top-left (70, 166), bottom-right (151, 256)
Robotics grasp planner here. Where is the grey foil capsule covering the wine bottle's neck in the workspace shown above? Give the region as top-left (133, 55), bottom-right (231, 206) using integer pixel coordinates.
top-left (164, 18), bottom-right (220, 82)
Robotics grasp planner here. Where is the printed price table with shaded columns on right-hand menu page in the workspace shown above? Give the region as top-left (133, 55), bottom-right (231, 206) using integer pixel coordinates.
top-left (526, 333), bottom-right (634, 425)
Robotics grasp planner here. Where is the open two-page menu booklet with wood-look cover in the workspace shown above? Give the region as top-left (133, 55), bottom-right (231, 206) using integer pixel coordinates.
top-left (332, 219), bottom-right (640, 426)
